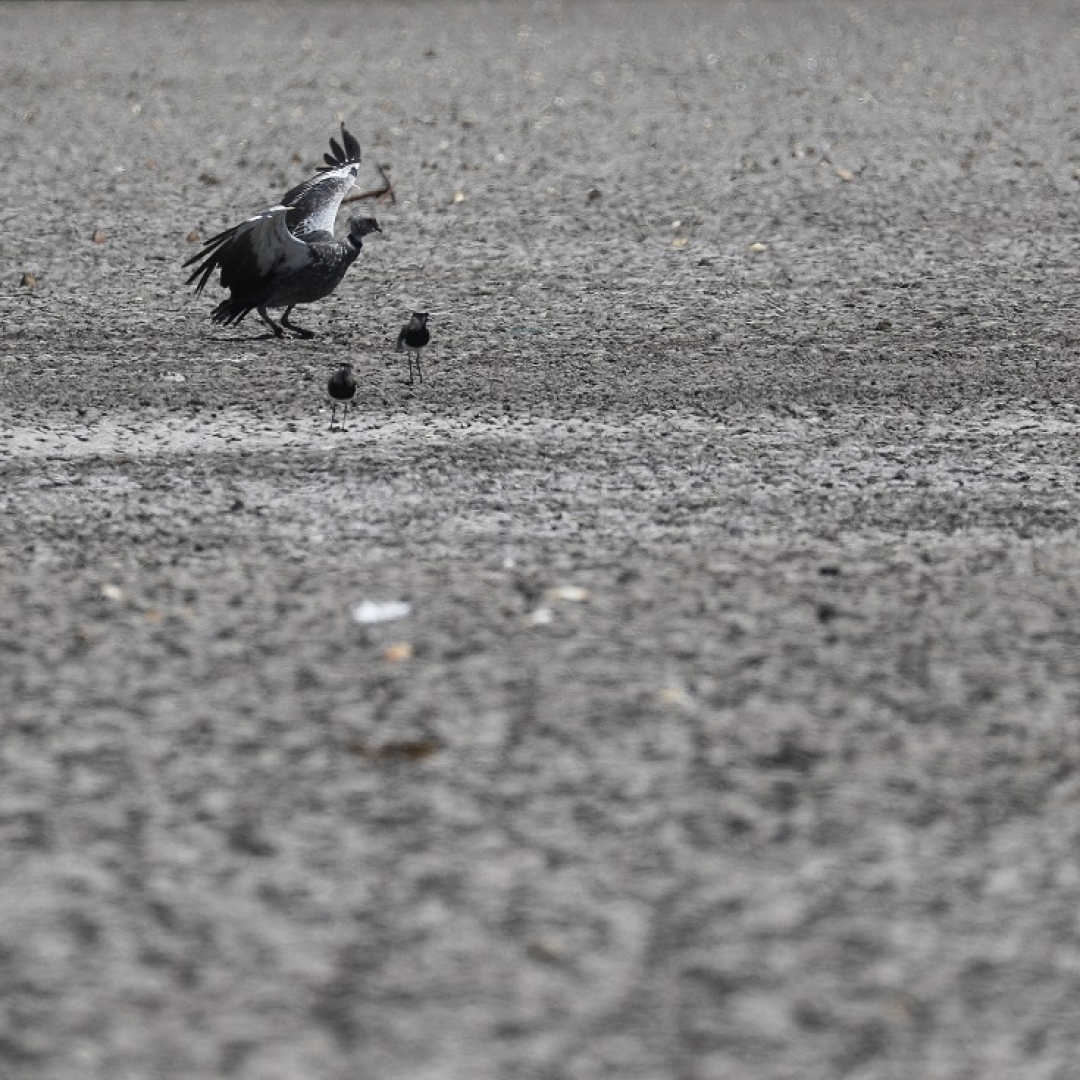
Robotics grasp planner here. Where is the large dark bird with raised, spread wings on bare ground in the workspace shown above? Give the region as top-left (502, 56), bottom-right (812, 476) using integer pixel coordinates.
top-left (184, 124), bottom-right (382, 338)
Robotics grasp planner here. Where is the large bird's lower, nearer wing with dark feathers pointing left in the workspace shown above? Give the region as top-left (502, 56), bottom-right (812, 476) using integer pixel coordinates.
top-left (184, 205), bottom-right (311, 295)
